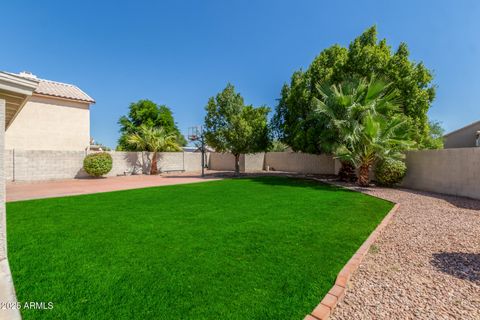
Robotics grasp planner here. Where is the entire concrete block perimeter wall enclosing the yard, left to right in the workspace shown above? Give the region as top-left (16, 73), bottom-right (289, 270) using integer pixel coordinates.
top-left (5, 148), bottom-right (480, 200)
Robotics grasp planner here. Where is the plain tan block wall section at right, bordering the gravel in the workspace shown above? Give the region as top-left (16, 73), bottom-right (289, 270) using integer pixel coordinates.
top-left (402, 147), bottom-right (480, 199)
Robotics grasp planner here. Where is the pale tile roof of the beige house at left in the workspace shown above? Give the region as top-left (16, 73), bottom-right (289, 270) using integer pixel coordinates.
top-left (12, 72), bottom-right (95, 103)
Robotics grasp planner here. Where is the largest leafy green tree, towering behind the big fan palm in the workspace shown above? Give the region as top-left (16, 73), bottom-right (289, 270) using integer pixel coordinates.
top-left (272, 26), bottom-right (435, 153)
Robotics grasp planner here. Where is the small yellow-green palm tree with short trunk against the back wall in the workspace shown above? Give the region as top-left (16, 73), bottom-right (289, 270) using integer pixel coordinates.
top-left (127, 125), bottom-right (182, 174)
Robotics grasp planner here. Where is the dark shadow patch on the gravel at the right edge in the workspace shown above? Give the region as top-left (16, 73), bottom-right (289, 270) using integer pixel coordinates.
top-left (430, 252), bottom-right (480, 284)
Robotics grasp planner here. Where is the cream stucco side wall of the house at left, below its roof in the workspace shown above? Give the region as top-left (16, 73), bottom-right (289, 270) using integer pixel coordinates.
top-left (5, 96), bottom-right (90, 151)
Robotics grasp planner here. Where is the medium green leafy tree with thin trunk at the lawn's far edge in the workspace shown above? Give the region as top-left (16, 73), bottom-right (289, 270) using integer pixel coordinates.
top-left (205, 84), bottom-right (270, 175)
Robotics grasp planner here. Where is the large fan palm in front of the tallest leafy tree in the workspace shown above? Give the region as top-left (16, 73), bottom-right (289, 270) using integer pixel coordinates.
top-left (313, 79), bottom-right (411, 186)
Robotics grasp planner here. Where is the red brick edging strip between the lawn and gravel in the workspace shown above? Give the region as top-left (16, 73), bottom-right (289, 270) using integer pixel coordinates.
top-left (303, 203), bottom-right (400, 320)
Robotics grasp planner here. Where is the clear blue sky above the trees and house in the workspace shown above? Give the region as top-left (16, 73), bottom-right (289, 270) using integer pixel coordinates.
top-left (0, 0), bottom-right (480, 147)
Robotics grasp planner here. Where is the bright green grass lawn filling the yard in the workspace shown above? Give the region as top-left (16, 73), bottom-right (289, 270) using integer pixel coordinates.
top-left (7, 177), bottom-right (392, 320)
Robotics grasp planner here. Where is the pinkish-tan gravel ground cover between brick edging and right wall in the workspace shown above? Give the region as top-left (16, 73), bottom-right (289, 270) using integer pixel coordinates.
top-left (331, 188), bottom-right (480, 320)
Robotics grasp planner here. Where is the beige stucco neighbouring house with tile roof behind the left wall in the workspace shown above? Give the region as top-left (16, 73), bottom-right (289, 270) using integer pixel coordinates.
top-left (0, 72), bottom-right (95, 150)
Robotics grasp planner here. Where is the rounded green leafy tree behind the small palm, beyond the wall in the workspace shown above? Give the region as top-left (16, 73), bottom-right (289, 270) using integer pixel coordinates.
top-left (117, 100), bottom-right (187, 151)
